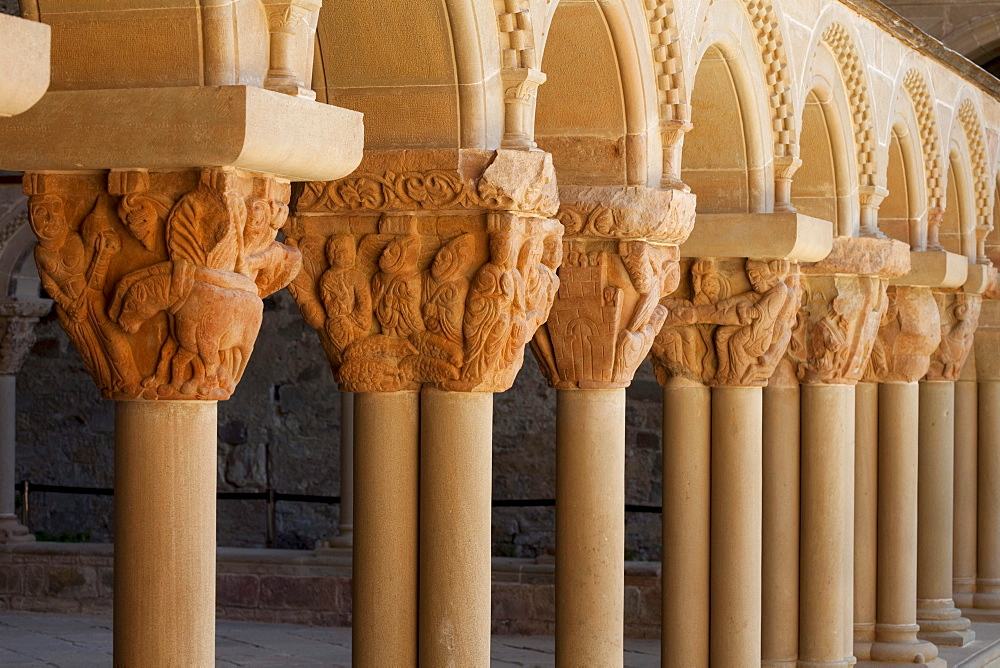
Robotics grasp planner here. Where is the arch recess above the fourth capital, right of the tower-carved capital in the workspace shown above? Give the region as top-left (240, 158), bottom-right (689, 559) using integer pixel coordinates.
top-left (682, 40), bottom-right (773, 213)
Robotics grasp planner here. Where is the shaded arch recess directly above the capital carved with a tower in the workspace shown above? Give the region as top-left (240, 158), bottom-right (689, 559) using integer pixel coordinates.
top-left (534, 0), bottom-right (663, 185)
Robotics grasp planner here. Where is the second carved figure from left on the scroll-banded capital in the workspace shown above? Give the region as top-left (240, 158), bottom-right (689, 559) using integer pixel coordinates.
top-left (372, 236), bottom-right (424, 339)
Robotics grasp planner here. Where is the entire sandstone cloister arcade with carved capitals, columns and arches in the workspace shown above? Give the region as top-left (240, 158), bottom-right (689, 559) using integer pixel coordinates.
top-left (0, 0), bottom-right (1000, 668)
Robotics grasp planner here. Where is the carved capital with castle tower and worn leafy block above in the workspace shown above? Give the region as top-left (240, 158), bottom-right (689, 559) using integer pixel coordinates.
top-left (532, 186), bottom-right (695, 389)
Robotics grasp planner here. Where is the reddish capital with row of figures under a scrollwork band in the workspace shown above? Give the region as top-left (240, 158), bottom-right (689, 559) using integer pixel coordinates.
top-left (285, 150), bottom-right (562, 392)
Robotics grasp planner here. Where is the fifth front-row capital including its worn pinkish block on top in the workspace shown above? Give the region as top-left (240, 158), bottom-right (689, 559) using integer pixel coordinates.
top-left (788, 237), bottom-right (910, 385)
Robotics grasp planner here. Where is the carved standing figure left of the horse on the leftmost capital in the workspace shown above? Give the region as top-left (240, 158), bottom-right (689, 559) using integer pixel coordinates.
top-left (29, 194), bottom-right (139, 391)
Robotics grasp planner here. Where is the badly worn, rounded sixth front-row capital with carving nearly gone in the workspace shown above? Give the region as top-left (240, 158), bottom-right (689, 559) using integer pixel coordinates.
top-left (864, 285), bottom-right (941, 383)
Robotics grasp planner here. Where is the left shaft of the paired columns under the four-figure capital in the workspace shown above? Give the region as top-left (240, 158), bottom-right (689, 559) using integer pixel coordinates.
top-left (351, 391), bottom-right (420, 668)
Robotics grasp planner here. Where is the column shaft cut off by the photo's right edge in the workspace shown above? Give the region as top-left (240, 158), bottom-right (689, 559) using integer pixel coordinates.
top-left (973, 380), bottom-right (1000, 610)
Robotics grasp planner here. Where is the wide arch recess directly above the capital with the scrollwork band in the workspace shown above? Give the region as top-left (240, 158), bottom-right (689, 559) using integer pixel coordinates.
top-left (313, 0), bottom-right (504, 149)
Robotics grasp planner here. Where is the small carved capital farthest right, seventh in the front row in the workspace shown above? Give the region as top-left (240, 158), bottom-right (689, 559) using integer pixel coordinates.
top-left (926, 290), bottom-right (983, 381)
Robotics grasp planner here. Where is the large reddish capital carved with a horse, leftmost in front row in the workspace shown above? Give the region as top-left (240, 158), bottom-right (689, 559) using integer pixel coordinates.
top-left (24, 168), bottom-right (301, 400)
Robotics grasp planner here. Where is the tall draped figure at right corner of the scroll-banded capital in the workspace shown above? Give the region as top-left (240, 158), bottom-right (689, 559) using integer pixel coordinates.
top-left (462, 229), bottom-right (524, 387)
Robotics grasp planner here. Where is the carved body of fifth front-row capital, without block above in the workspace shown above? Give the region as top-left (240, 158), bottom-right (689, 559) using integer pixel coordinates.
top-left (787, 274), bottom-right (886, 385)
